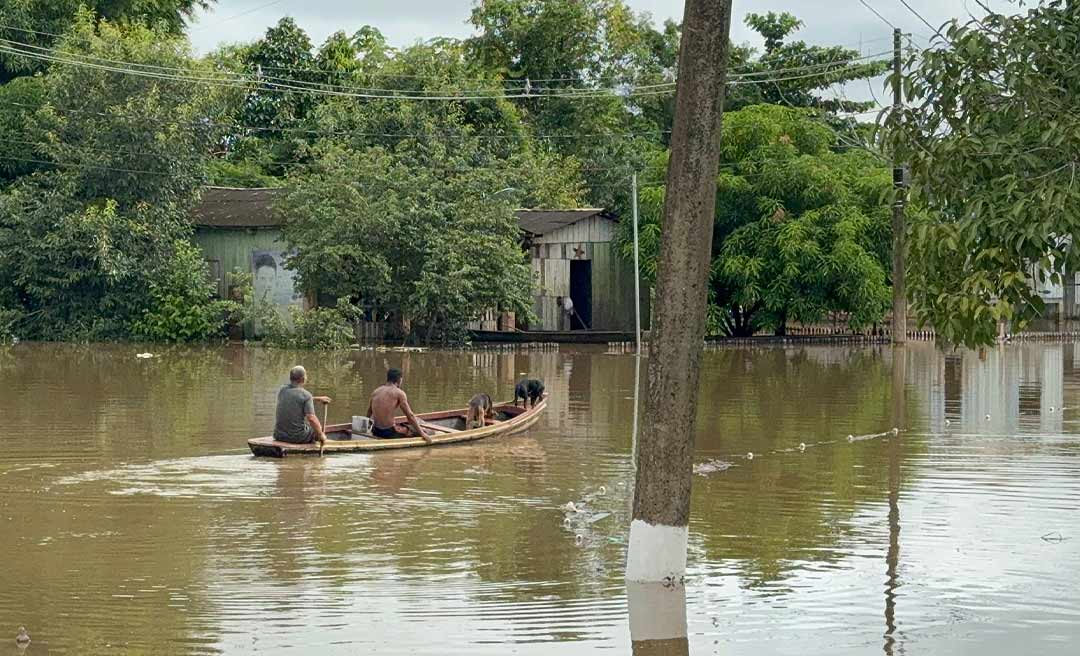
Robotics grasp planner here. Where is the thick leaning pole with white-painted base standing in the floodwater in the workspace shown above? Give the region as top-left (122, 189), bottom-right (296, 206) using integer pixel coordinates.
top-left (626, 0), bottom-right (731, 583)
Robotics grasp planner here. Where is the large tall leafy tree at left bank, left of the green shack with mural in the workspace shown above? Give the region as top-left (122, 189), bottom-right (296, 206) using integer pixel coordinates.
top-left (0, 12), bottom-right (225, 338)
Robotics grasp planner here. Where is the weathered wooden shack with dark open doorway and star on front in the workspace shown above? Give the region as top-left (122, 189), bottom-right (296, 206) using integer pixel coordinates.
top-left (517, 209), bottom-right (649, 332)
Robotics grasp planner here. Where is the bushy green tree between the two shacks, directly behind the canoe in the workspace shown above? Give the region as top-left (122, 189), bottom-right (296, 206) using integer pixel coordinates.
top-left (279, 146), bottom-right (532, 342)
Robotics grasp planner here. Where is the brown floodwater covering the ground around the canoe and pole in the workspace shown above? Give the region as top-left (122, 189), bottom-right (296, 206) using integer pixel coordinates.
top-left (0, 344), bottom-right (1080, 655)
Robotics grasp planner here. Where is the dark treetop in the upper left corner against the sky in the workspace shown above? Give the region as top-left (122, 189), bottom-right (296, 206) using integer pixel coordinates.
top-left (0, 0), bottom-right (215, 84)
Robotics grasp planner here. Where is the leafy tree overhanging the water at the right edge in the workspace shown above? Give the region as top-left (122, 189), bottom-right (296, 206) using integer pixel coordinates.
top-left (885, 1), bottom-right (1080, 346)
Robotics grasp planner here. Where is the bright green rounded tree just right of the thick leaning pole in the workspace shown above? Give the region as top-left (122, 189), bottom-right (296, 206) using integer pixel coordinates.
top-left (622, 105), bottom-right (891, 335)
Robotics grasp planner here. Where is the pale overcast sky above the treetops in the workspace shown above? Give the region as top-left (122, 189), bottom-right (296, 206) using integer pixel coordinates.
top-left (191, 0), bottom-right (1011, 53)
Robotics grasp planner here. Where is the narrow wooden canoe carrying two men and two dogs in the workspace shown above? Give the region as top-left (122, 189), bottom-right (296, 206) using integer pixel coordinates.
top-left (247, 394), bottom-right (548, 458)
